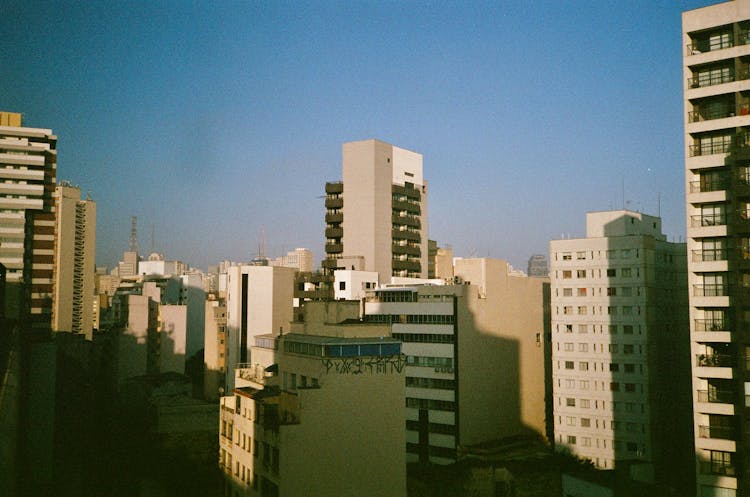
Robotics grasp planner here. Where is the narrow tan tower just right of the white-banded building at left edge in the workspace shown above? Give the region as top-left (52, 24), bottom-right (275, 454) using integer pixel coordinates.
top-left (52, 183), bottom-right (98, 340)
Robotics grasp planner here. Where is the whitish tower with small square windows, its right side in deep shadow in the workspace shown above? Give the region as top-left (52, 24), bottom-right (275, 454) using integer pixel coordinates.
top-left (550, 211), bottom-right (692, 490)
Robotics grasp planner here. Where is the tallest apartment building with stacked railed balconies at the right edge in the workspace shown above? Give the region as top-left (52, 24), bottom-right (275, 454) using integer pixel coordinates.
top-left (682, 4), bottom-right (750, 496)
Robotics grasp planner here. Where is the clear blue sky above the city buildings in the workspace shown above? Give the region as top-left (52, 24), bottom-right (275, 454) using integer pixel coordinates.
top-left (0, 0), bottom-right (715, 269)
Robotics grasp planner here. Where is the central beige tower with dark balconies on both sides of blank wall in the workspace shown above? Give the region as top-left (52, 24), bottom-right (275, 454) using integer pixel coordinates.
top-left (323, 140), bottom-right (429, 281)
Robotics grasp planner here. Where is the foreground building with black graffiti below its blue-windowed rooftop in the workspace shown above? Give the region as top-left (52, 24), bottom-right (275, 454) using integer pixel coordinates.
top-left (220, 302), bottom-right (406, 497)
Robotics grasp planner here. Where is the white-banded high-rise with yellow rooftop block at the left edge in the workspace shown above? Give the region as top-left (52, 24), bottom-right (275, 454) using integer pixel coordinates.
top-left (0, 112), bottom-right (57, 332)
